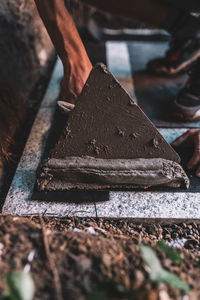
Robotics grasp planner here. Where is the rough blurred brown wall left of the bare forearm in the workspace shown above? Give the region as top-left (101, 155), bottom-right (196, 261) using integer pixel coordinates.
top-left (0, 0), bottom-right (53, 181)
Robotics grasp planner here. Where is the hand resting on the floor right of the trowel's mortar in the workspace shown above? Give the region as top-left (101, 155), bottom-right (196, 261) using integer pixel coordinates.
top-left (172, 129), bottom-right (200, 177)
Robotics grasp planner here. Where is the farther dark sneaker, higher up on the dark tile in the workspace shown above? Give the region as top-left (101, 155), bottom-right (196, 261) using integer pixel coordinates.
top-left (147, 38), bottom-right (200, 76)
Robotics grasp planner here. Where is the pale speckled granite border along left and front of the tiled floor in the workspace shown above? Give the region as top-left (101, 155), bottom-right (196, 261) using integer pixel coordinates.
top-left (3, 55), bottom-right (200, 222)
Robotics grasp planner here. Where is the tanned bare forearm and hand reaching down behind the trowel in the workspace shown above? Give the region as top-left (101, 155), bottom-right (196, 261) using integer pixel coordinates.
top-left (35, 0), bottom-right (92, 103)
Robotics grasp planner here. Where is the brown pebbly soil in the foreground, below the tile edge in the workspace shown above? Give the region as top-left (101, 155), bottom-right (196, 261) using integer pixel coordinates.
top-left (0, 216), bottom-right (200, 300)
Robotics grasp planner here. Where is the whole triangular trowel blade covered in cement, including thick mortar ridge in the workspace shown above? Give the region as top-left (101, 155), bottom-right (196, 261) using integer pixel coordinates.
top-left (38, 64), bottom-right (189, 191)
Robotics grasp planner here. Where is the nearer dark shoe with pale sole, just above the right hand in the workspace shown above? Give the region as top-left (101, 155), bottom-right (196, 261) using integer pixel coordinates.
top-left (173, 60), bottom-right (200, 122)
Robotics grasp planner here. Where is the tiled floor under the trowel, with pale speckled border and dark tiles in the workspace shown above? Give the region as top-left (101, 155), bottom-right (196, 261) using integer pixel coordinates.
top-left (3, 41), bottom-right (200, 220)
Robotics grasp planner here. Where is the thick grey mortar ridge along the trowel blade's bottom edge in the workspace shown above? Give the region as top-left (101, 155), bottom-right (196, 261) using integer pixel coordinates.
top-left (38, 157), bottom-right (189, 191)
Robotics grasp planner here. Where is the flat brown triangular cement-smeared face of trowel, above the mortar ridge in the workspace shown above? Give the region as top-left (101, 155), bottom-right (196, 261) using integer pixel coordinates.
top-left (51, 64), bottom-right (180, 162)
